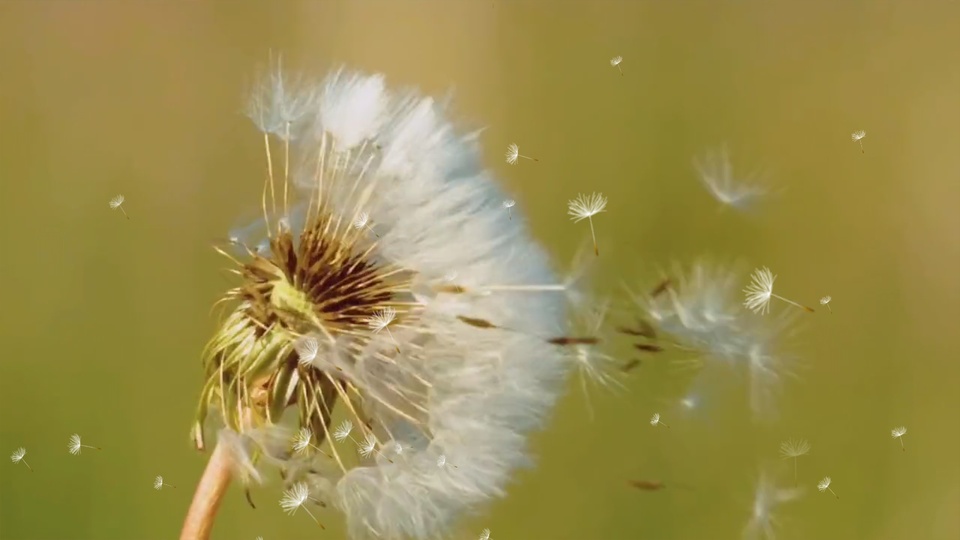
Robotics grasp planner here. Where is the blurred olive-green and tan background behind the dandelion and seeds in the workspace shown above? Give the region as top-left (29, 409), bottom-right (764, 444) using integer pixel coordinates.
top-left (0, 0), bottom-right (960, 540)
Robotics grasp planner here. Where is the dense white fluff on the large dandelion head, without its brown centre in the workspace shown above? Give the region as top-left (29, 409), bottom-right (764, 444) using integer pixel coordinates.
top-left (240, 65), bottom-right (573, 538)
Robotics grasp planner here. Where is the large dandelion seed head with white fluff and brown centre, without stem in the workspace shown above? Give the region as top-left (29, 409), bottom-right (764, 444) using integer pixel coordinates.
top-left (194, 65), bottom-right (573, 538)
